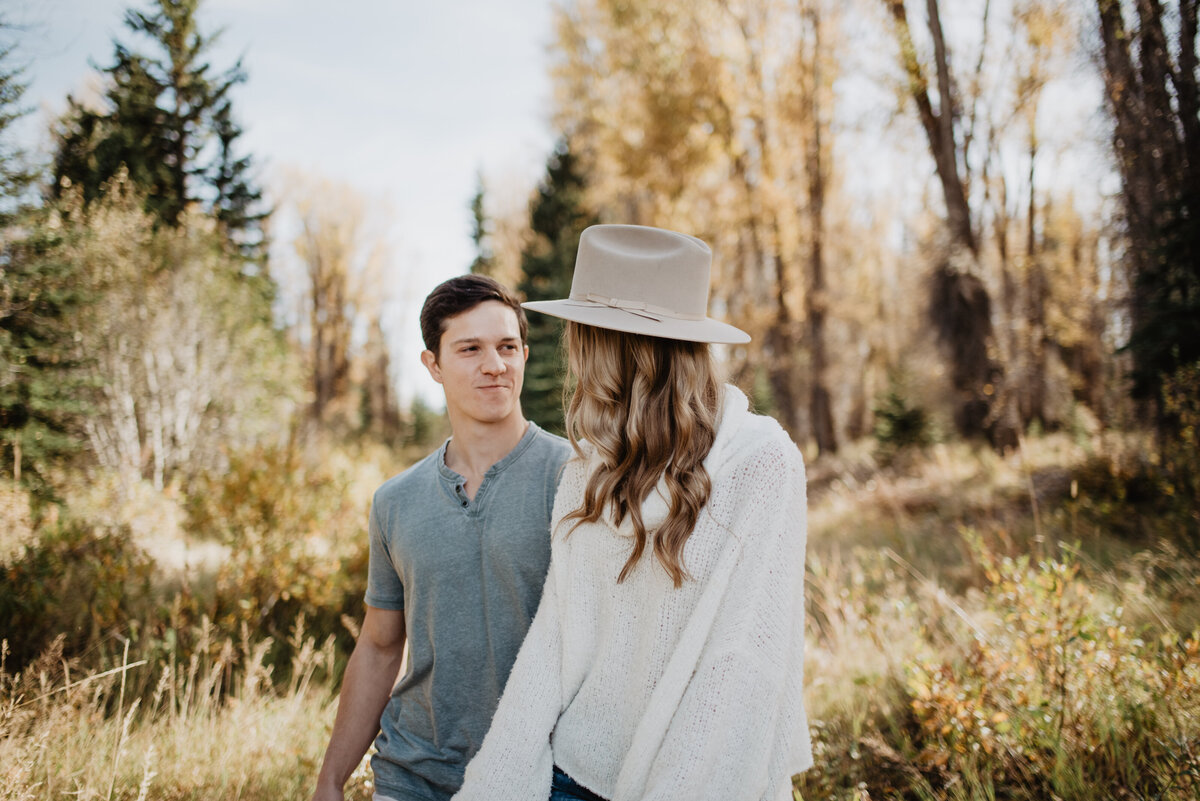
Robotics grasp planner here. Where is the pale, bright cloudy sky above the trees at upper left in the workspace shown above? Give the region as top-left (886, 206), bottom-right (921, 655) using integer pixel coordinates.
top-left (4, 0), bottom-right (553, 399)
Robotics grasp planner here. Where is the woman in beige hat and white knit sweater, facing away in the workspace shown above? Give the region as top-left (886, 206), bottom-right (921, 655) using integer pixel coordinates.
top-left (455, 225), bottom-right (812, 801)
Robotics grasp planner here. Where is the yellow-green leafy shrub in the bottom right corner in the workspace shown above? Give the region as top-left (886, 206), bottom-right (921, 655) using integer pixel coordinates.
top-left (908, 541), bottom-right (1200, 801)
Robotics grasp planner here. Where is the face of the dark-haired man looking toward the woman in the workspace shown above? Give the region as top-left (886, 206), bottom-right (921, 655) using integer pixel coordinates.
top-left (421, 301), bottom-right (529, 423)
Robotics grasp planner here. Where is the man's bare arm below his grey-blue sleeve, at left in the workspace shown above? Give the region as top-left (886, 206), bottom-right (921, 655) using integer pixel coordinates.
top-left (312, 607), bottom-right (406, 801)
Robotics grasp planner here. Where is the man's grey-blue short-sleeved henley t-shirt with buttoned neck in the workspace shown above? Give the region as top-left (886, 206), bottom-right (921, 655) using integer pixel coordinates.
top-left (366, 422), bottom-right (571, 801)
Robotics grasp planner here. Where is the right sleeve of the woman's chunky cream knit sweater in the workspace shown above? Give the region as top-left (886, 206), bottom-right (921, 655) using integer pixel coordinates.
top-left (633, 432), bottom-right (810, 801)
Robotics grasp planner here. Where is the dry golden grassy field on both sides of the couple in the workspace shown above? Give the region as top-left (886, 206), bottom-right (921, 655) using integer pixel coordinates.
top-left (0, 434), bottom-right (1200, 801)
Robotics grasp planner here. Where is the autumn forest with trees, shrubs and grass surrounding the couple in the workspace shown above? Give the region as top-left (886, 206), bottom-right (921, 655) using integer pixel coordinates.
top-left (0, 0), bottom-right (1200, 799)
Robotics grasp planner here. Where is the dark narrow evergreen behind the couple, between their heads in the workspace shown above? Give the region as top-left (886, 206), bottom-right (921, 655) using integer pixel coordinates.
top-left (517, 139), bottom-right (598, 434)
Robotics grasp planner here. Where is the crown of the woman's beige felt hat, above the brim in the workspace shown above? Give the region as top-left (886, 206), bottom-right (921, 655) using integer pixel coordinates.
top-left (571, 224), bottom-right (713, 320)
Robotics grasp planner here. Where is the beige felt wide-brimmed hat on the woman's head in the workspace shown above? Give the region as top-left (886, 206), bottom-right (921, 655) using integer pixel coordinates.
top-left (522, 225), bottom-right (750, 344)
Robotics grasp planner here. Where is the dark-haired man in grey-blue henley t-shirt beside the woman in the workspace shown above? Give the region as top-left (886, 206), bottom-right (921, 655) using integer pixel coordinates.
top-left (313, 276), bottom-right (570, 801)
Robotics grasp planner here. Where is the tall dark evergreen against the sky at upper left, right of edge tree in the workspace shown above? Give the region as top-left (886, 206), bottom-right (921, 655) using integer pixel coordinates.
top-left (53, 0), bottom-right (265, 260)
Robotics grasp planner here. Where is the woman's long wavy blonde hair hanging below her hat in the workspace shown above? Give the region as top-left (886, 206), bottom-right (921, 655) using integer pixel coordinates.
top-left (564, 323), bottom-right (720, 588)
